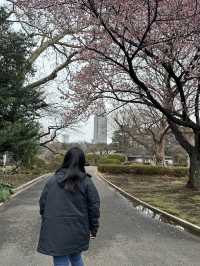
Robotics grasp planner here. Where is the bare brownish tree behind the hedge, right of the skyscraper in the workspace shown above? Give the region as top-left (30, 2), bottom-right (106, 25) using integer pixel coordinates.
top-left (114, 105), bottom-right (169, 165)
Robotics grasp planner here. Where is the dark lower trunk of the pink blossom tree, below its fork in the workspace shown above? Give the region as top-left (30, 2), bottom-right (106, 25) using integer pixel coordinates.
top-left (187, 152), bottom-right (200, 190)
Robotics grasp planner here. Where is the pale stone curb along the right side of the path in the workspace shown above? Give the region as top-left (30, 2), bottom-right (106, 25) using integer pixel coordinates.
top-left (98, 172), bottom-right (200, 236)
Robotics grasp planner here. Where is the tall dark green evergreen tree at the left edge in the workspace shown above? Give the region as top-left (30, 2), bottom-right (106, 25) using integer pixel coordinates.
top-left (0, 8), bottom-right (45, 165)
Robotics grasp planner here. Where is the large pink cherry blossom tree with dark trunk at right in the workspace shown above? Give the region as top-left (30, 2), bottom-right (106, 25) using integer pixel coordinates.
top-left (17, 0), bottom-right (200, 188)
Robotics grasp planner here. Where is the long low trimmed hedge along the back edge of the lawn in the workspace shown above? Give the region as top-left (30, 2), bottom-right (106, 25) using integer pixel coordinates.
top-left (98, 164), bottom-right (188, 177)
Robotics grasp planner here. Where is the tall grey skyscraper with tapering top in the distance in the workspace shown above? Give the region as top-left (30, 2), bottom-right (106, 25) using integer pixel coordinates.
top-left (93, 100), bottom-right (107, 144)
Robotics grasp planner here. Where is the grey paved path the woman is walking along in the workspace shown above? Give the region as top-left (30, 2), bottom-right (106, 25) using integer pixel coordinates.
top-left (0, 168), bottom-right (200, 266)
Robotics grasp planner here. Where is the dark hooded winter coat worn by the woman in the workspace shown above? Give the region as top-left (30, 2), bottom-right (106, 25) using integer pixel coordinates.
top-left (37, 170), bottom-right (100, 256)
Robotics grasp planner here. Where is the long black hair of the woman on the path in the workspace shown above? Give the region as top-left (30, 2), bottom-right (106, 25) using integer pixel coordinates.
top-left (57, 147), bottom-right (86, 192)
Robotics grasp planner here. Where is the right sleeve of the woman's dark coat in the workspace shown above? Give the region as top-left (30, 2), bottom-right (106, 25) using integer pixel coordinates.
top-left (87, 179), bottom-right (100, 237)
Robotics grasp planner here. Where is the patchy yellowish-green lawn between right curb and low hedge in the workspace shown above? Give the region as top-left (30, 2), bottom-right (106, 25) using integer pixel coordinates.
top-left (103, 173), bottom-right (200, 226)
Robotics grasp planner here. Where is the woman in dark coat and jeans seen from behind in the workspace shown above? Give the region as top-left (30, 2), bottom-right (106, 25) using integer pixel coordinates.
top-left (37, 148), bottom-right (100, 266)
